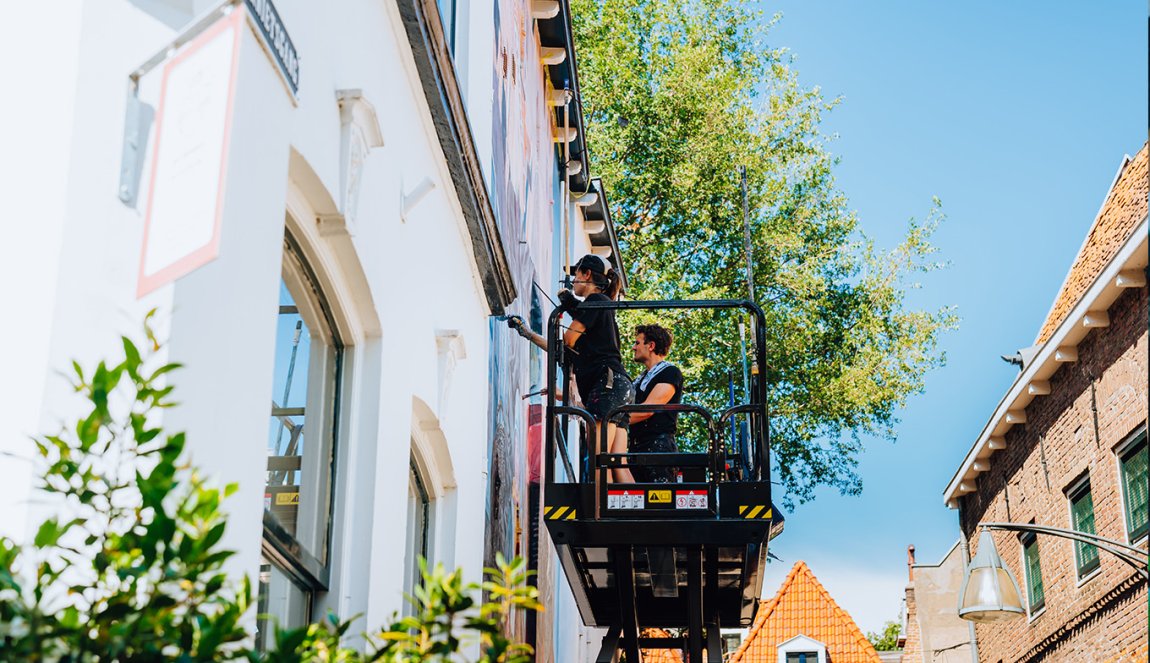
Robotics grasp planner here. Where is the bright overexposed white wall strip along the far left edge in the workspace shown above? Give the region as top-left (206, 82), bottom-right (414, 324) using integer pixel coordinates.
top-left (0, 0), bottom-right (82, 541)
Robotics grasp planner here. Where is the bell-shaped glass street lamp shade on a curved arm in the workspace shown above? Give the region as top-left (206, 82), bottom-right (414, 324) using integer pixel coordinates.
top-left (958, 530), bottom-right (1025, 624)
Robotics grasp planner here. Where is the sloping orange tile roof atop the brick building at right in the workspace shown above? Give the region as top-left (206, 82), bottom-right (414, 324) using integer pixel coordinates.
top-left (1035, 144), bottom-right (1150, 345)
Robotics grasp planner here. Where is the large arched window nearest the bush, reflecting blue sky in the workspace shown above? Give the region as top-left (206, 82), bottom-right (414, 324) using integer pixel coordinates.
top-left (258, 232), bottom-right (344, 647)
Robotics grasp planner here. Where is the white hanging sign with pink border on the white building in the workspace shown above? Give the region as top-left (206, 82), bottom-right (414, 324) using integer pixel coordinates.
top-left (137, 11), bottom-right (244, 296)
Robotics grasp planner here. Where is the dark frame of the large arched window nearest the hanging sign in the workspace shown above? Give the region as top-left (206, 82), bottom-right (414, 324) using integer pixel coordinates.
top-left (261, 229), bottom-right (347, 638)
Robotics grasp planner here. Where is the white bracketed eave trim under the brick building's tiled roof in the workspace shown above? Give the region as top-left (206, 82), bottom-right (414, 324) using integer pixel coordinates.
top-left (943, 218), bottom-right (1150, 503)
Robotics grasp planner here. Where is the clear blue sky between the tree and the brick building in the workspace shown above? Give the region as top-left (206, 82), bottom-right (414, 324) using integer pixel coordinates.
top-left (764, 0), bottom-right (1148, 631)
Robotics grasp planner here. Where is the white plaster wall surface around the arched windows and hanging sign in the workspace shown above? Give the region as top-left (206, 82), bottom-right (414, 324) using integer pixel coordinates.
top-left (0, 0), bottom-right (501, 629)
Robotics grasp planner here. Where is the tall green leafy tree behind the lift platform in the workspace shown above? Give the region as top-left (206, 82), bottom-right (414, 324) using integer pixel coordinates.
top-left (572, 0), bottom-right (956, 504)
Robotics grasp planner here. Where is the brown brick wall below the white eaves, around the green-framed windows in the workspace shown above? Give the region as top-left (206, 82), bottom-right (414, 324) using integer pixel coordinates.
top-left (961, 287), bottom-right (1148, 663)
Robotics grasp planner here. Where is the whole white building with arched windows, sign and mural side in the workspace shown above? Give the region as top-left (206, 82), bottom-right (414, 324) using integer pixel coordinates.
top-left (0, 0), bottom-right (618, 661)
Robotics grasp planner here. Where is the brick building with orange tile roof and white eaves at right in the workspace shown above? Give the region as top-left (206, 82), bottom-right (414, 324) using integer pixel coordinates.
top-left (945, 146), bottom-right (1148, 662)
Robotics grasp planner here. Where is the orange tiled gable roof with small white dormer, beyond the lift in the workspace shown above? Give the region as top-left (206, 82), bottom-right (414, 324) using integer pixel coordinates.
top-left (728, 562), bottom-right (881, 663)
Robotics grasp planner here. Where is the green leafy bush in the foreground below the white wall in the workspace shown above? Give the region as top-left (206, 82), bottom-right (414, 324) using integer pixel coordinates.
top-left (0, 314), bottom-right (541, 663)
